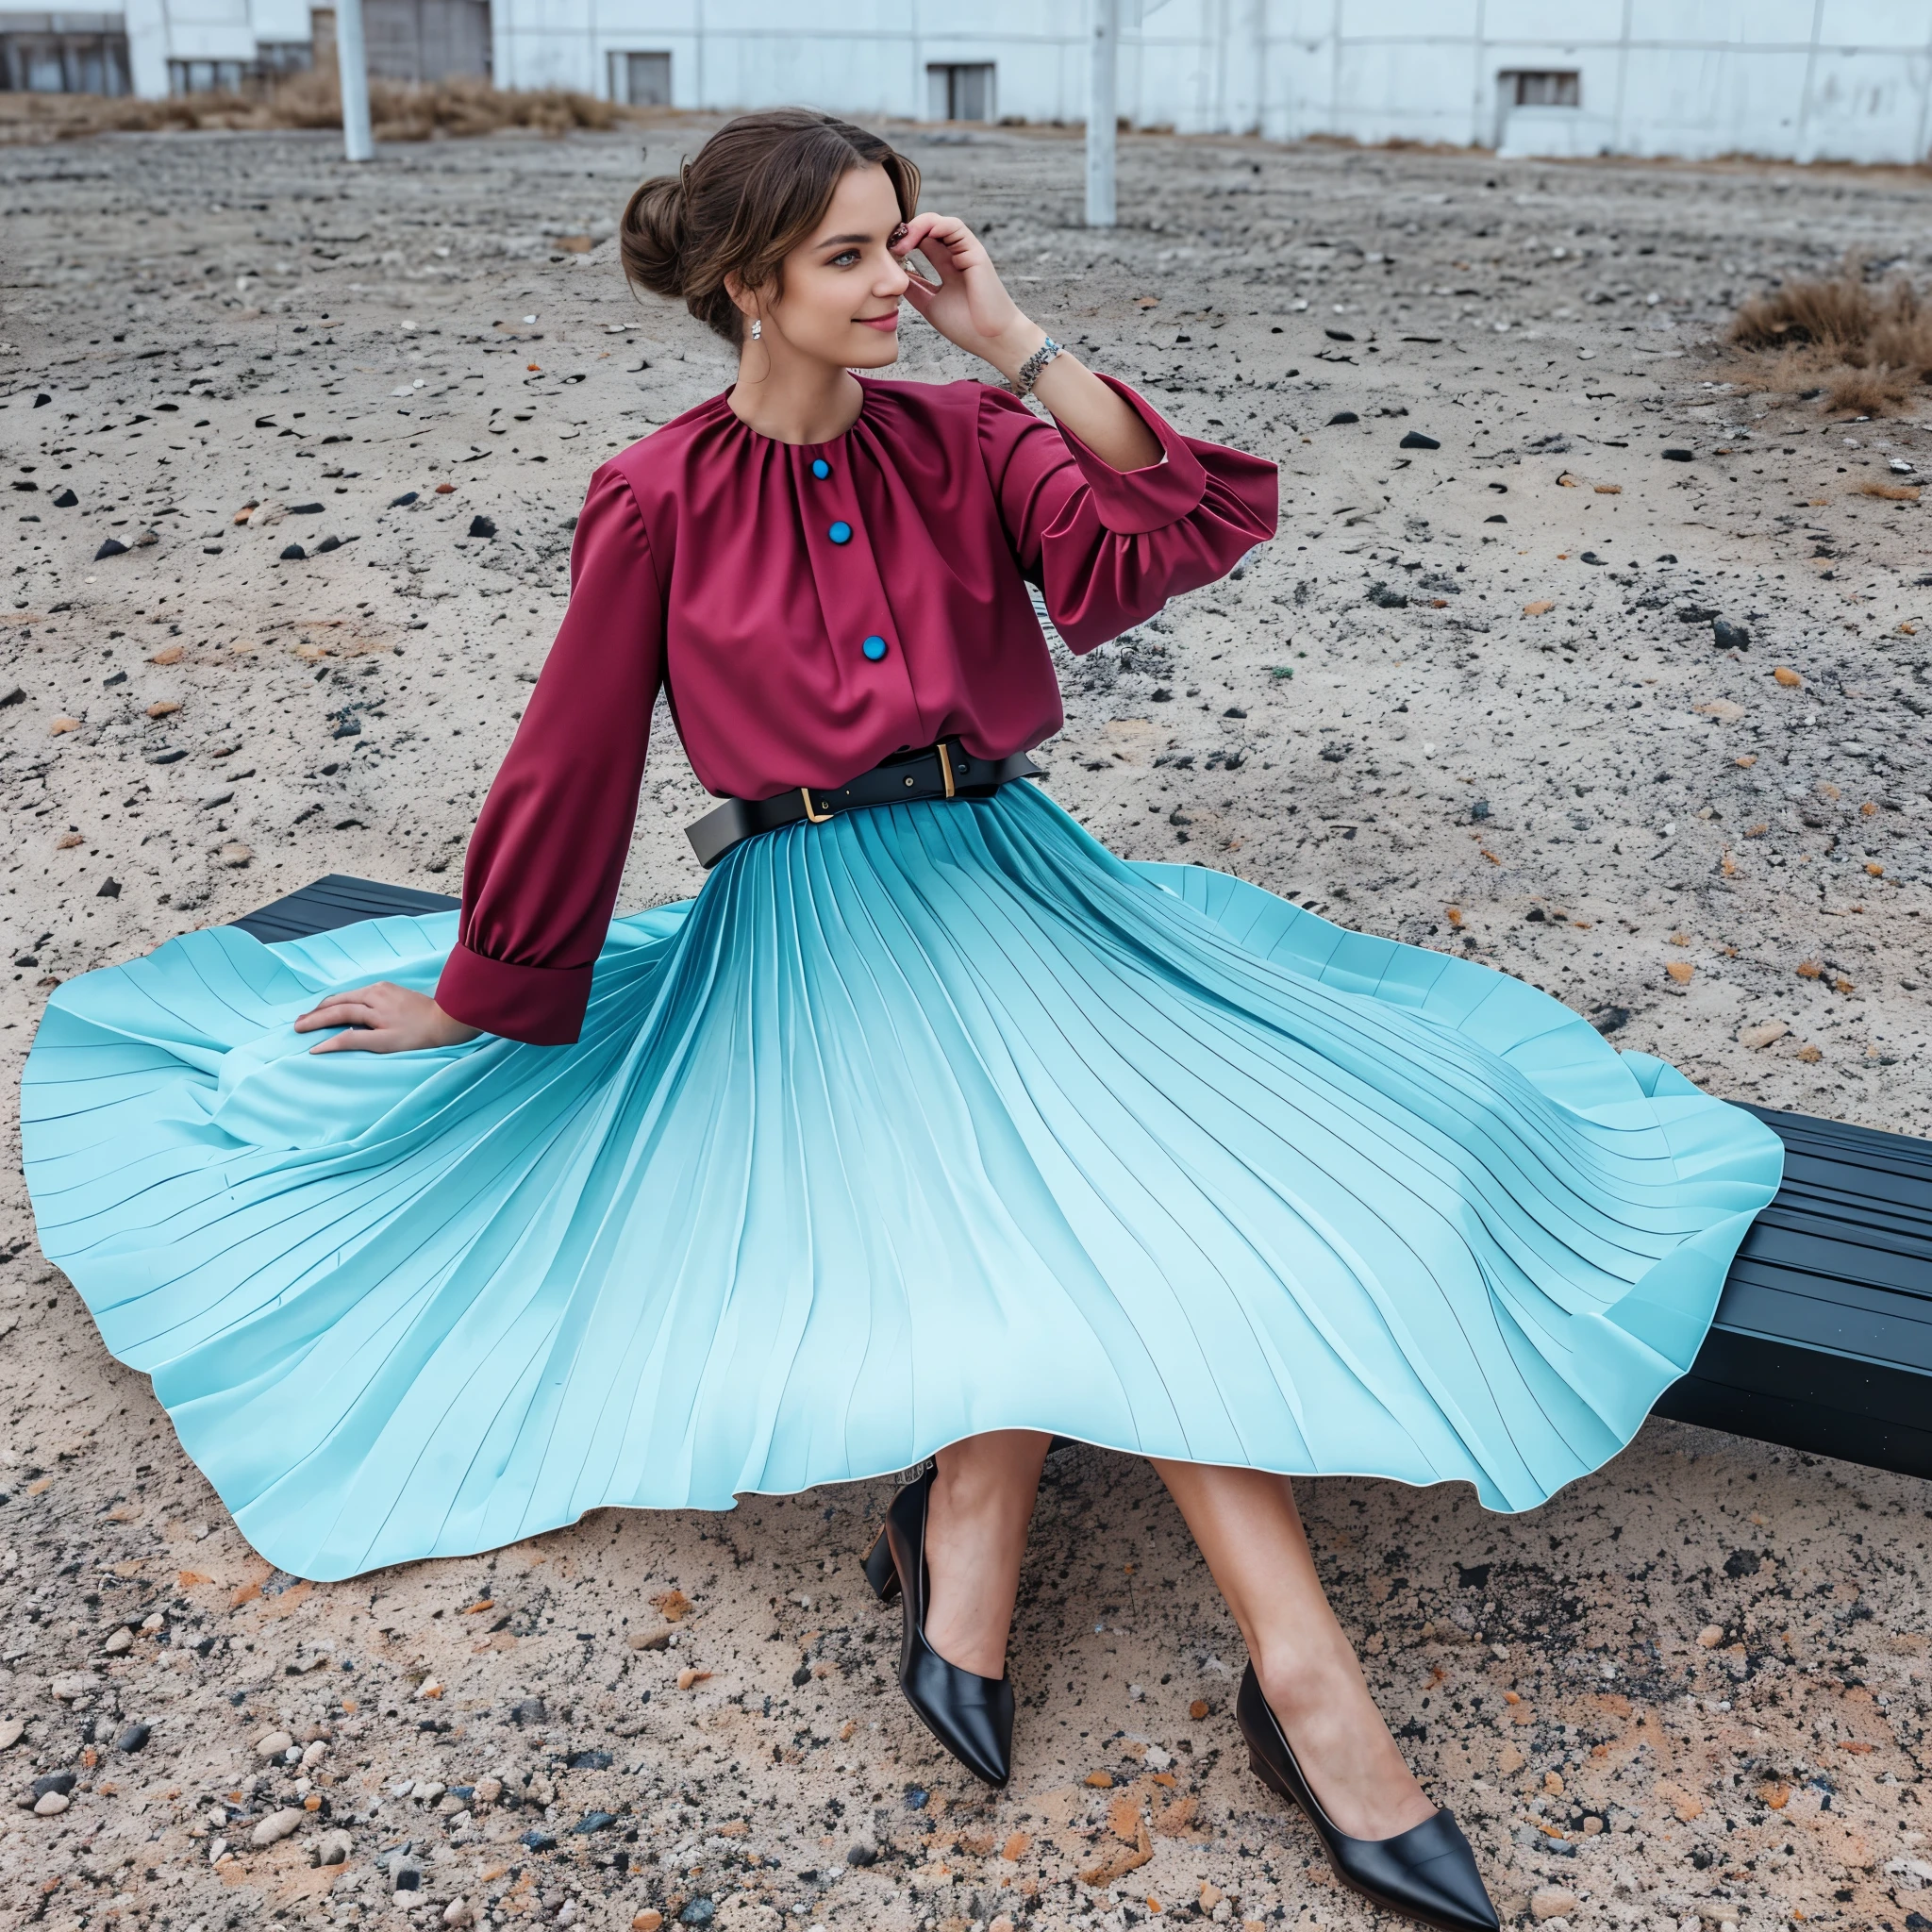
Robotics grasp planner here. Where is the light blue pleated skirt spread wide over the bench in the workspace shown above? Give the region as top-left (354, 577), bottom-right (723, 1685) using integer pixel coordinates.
top-left (24, 784), bottom-right (1781, 1578)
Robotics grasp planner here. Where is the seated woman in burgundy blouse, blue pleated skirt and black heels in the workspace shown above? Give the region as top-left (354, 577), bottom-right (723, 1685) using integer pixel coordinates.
top-left (27, 112), bottom-right (1779, 1928)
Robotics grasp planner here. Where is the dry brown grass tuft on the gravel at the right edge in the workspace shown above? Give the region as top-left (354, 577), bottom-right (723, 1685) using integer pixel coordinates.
top-left (1727, 263), bottom-right (1932, 415)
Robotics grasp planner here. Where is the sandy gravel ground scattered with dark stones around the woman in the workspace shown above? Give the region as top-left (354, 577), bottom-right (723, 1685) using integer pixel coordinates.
top-left (0, 120), bottom-right (1932, 1932)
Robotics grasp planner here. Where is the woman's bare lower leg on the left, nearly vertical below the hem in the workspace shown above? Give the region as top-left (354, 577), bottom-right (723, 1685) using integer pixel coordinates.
top-left (925, 1430), bottom-right (1051, 1677)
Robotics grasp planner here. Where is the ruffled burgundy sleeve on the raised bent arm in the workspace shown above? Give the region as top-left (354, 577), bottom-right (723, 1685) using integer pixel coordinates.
top-left (979, 375), bottom-right (1277, 651)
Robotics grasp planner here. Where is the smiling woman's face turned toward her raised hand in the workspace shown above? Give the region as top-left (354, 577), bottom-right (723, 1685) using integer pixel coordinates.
top-left (746, 166), bottom-right (908, 369)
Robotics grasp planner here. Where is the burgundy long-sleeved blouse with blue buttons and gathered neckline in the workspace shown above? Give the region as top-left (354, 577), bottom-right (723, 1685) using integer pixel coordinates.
top-left (437, 376), bottom-right (1275, 1045)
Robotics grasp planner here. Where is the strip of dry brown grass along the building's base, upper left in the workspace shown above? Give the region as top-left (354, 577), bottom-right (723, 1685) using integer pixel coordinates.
top-left (0, 70), bottom-right (626, 143)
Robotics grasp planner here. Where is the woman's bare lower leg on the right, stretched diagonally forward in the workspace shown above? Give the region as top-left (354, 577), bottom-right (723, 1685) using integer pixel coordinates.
top-left (1154, 1460), bottom-right (1436, 1838)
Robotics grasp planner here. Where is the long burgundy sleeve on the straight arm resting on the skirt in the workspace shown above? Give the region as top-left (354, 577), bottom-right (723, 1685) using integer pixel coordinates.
top-left (437, 468), bottom-right (665, 1047)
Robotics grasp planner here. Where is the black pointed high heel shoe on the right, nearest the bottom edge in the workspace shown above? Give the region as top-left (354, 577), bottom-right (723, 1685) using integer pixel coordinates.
top-left (1235, 1663), bottom-right (1501, 1932)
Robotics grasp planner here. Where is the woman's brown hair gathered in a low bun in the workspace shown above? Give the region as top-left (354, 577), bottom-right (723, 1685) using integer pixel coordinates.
top-left (618, 108), bottom-right (920, 344)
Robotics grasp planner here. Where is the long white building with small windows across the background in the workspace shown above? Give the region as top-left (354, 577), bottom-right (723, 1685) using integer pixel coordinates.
top-left (0, 0), bottom-right (1932, 162)
